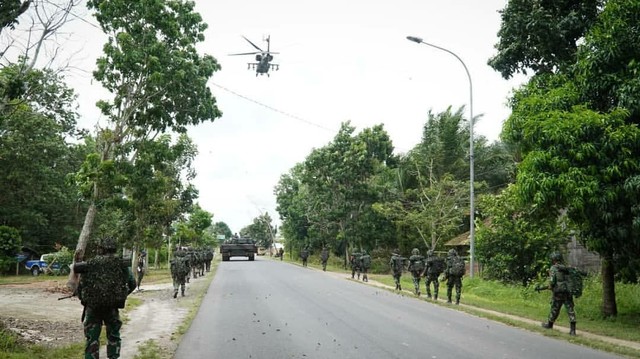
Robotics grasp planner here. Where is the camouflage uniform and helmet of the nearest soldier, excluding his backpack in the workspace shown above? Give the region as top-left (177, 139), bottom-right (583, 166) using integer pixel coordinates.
top-left (78, 238), bottom-right (136, 359)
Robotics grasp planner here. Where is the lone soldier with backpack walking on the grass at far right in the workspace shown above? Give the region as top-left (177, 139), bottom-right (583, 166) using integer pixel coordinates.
top-left (535, 252), bottom-right (585, 336)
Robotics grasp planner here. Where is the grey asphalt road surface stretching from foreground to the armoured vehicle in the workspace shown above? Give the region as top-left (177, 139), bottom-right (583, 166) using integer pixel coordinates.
top-left (174, 257), bottom-right (616, 359)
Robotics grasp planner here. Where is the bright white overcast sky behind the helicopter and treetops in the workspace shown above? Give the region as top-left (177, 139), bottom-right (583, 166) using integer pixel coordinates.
top-left (17, 0), bottom-right (524, 232)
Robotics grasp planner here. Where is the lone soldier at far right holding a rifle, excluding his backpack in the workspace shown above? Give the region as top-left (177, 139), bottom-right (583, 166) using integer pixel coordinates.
top-left (536, 252), bottom-right (576, 336)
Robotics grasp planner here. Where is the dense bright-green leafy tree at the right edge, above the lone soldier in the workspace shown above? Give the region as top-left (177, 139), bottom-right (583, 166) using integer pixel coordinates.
top-left (494, 0), bottom-right (640, 316)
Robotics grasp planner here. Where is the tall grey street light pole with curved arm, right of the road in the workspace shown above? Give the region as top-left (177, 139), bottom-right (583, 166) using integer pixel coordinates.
top-left (407, 36), bottom-right (475, 278)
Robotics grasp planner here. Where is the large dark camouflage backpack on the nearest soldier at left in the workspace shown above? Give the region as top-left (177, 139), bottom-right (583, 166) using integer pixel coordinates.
top-left (79, 256), bottom-right (129, 308)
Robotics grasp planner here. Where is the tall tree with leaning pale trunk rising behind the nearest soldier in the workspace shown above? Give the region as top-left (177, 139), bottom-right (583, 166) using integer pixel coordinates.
top-left (69, 0), bottom-right (221, 287)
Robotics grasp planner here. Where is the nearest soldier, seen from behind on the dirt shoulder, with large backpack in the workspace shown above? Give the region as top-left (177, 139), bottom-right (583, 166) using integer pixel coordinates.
top-left (74, 237), bottom-right (136, 359)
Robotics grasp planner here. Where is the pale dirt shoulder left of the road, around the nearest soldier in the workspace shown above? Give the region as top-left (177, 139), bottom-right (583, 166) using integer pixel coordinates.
top-left (0, 272), bottom-right (213, 358)
